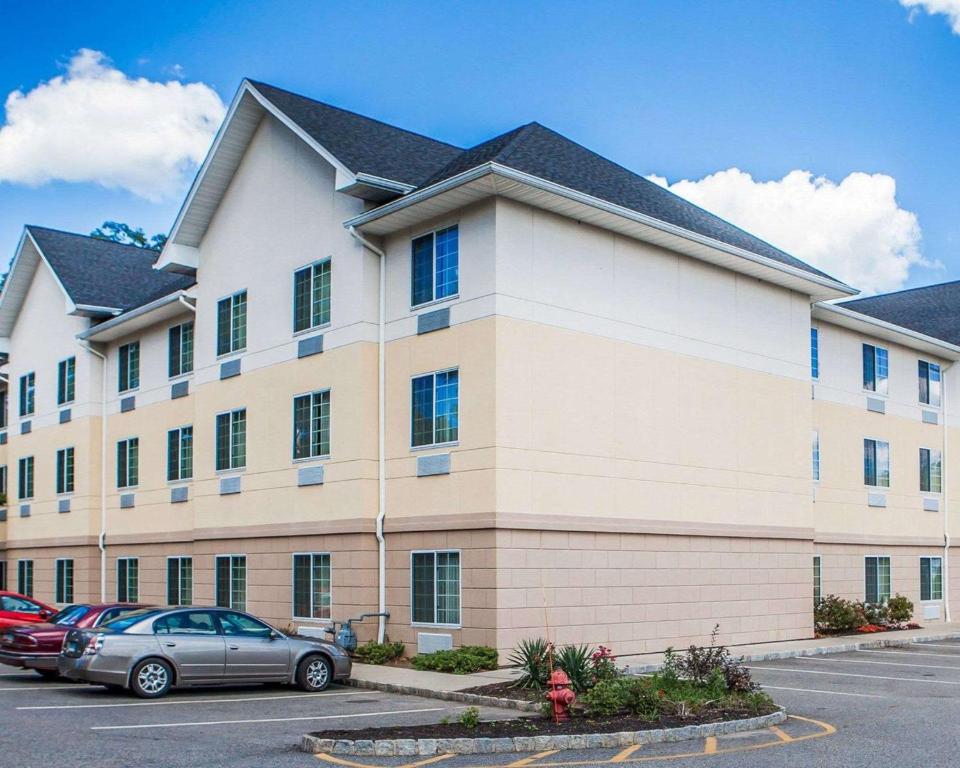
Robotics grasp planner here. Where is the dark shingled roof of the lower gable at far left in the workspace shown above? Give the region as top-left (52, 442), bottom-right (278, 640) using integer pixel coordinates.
top-left (27, 226), bottom-right (196, 311)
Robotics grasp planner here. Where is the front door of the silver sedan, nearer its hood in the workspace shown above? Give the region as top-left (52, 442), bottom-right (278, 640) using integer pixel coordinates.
top-left (218, 611), bottom-right (290, 682)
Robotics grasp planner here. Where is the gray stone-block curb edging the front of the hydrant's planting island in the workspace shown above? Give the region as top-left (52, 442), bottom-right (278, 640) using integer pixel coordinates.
top-left (300, 709), bottom-right (787, 757)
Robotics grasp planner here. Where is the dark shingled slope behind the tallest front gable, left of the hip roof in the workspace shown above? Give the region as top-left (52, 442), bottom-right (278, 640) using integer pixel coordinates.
top-left (249, 80), bottom-right (463, 186)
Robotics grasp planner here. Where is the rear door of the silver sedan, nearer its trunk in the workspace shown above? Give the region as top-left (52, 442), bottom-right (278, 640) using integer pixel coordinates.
top-left (153, 610), bottom-right (225, 685)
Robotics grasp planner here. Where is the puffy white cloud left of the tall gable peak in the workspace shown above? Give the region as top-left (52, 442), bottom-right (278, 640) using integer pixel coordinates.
top-left (0, 48), bottom-right (226, 200)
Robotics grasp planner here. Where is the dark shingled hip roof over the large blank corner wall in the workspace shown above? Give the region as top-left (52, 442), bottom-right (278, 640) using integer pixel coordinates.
top-left (422, 123), bottom-right (835, 280)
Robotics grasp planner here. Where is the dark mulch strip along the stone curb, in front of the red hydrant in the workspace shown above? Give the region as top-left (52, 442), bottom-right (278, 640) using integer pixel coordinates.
top-left (310, 704), bottom-right (776, 741)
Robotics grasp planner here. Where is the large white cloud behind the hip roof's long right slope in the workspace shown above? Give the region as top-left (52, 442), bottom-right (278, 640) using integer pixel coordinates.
top-left (649, 168), bottom-right (931, 293)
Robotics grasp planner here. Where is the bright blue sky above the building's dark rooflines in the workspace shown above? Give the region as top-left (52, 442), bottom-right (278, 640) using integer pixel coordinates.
top-left (0, 0), bottom-right (960, 290)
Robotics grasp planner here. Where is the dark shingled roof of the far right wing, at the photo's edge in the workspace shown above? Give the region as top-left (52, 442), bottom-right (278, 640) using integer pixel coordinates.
top-left (838, 280), bottom-right (960, 345)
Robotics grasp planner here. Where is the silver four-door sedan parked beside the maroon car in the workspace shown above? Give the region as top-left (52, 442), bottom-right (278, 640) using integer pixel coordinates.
top-left (57, 607), bottom-right (351, 699)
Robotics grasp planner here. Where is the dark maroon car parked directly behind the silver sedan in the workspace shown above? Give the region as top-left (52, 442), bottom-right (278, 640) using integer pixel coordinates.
top-left (0, 603), bottom-right (149, 678)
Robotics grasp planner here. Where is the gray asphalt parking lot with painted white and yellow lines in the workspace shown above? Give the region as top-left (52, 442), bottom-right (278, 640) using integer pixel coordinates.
top-left (0, 641), bottom-right (960, 768)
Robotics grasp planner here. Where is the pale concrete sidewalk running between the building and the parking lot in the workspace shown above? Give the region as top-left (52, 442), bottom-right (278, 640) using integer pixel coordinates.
top-left (351, 623), bottom-right (960, 701)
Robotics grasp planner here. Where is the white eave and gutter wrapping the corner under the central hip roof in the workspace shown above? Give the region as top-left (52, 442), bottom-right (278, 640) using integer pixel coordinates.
top-left (344, 162), bottom-right (858, 301)
